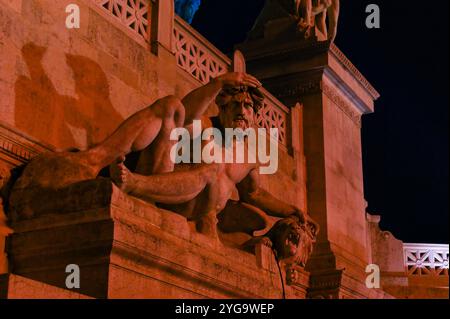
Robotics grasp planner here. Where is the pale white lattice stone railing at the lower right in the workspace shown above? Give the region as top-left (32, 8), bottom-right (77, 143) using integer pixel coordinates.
top-left (403, 244), bottom-right (449, 277)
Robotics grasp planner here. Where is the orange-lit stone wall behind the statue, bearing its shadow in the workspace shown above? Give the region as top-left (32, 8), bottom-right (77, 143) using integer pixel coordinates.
top-left (0, 1), bottom-right (170, 149)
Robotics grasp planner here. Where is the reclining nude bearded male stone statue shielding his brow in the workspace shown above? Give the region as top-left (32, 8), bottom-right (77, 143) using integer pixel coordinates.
top-left (10, 62), bottom-right (318, 264)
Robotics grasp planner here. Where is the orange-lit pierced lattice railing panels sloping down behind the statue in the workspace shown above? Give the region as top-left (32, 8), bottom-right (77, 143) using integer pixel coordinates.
top-left (92, 0), bottom-right (289, 148)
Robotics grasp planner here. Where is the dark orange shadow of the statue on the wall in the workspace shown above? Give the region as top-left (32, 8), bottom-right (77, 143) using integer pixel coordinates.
top-left (15, 42), bottom-right (123, 149)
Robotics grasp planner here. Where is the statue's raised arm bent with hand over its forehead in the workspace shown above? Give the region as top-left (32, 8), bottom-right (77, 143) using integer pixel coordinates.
top-left (182, 72), bottom-right (261, 126)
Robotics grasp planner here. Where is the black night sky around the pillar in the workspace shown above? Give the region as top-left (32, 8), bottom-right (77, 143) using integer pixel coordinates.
top-left (192, 0), bottom-right (449, 243)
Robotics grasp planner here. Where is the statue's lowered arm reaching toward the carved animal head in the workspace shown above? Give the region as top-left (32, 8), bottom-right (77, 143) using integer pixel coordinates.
top-left (237, 168), bottom-right (305, 221)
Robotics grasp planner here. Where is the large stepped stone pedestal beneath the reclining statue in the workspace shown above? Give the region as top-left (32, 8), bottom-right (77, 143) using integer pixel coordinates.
top-left (0, 179), bottom-right (309, 298)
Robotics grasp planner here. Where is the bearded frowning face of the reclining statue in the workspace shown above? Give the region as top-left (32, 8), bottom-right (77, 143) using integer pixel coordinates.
top-left (219, 92), bottom-right (255, 130)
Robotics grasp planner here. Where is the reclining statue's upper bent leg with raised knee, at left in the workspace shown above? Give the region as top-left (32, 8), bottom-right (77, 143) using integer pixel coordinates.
top-left (9, 97), bottom-right (184, 195)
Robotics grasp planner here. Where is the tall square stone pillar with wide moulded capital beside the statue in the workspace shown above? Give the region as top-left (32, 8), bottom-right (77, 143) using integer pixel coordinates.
top-left (239, 29), bottom-right (386, 298)
